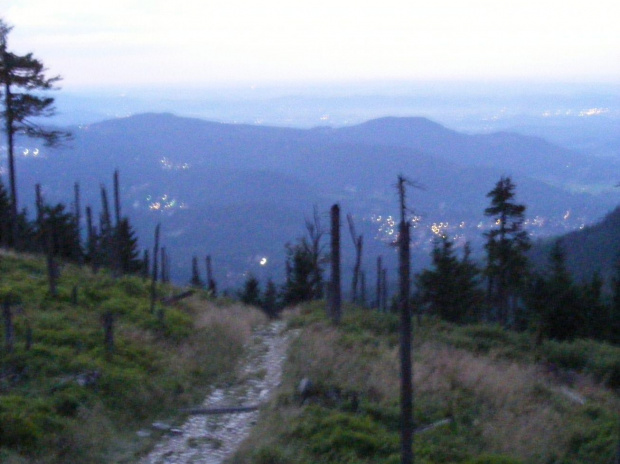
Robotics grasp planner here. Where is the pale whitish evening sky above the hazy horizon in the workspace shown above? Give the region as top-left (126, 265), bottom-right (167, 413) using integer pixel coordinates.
top-left (0, 0), bottom-right (620, 89)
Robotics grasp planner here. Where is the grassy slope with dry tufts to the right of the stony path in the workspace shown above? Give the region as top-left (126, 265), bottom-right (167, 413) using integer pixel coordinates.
top-left (230, 304), bottom-right (620, 464)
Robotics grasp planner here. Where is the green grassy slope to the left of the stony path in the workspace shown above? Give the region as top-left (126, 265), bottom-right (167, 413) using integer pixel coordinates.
top-left (0, 253), bottom-right (264, 464)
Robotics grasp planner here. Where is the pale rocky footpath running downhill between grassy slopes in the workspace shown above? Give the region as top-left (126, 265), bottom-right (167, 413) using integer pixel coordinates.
top-left (140, 321), bottom-right (291, 464)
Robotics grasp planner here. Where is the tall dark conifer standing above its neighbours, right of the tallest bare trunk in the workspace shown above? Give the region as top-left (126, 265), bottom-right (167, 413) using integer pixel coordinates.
top-left (484, 177), bottom-right (530, 325)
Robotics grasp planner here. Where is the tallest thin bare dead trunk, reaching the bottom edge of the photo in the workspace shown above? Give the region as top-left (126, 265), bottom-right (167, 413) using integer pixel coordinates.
top-left (398, 176), bottom-right (414, 464)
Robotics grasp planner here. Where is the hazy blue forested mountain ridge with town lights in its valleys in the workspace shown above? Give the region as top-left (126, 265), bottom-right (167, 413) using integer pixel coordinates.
top-left (10, 113), bottom-right (619, 282)
